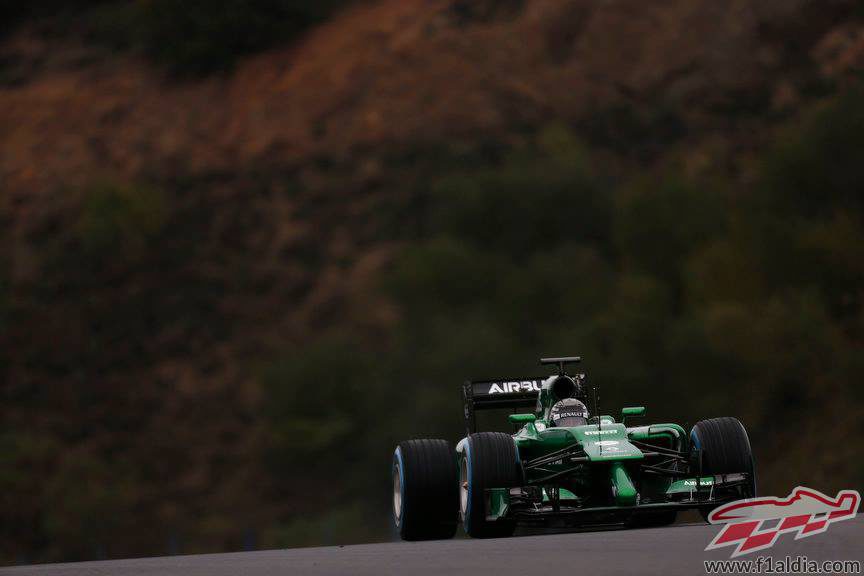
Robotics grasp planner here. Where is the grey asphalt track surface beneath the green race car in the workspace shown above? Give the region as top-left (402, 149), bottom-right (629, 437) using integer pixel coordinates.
top-left (0, 517), bottom-right (864, 576)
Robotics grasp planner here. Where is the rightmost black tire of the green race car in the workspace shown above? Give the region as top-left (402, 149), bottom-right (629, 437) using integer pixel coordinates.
top-left (690, 416), bottom-right (756, 520)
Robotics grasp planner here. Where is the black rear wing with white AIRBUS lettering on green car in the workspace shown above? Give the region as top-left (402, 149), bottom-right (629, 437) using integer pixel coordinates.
top-left (462, 376), bottom-right (548, 434)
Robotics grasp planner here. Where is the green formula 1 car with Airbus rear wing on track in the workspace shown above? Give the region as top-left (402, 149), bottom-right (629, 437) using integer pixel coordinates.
top-left (393, 357), bottom-right (756, 540)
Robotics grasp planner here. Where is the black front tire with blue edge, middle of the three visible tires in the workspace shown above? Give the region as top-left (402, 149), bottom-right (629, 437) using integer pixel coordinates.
top-left (459, 432), bottom-right (522, 538)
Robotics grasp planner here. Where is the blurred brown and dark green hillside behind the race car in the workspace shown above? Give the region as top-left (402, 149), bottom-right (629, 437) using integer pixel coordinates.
top-left (0, 0), bottom-right (864, 563)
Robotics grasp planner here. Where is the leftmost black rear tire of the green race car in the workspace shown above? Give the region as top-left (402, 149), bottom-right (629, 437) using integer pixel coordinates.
top-left (393, 439), bottom-right (459, 540)
